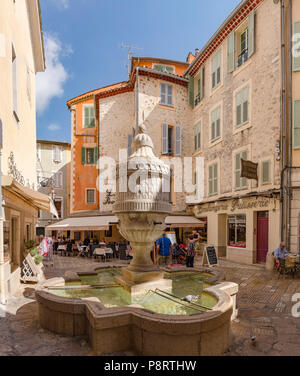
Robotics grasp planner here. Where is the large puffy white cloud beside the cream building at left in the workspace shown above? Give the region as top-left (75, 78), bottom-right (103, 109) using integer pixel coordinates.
top-left (36, 34), bottom-right (72, 113)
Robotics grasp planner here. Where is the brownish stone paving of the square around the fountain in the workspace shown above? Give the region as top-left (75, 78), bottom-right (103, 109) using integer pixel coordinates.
top-left (0, 256), bottom-right (300, 356)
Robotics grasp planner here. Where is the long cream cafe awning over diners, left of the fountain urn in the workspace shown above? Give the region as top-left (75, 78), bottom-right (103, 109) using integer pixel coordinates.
top-left (46, 215), bottom-right (118, 231)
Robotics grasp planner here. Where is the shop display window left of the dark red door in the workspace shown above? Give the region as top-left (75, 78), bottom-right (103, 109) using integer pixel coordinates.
top-left (228, 215), bottom-right (246, 248)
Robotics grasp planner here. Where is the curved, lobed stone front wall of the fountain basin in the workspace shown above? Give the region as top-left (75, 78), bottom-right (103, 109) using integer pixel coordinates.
top-left (36, 270), bottom-right (234, 356)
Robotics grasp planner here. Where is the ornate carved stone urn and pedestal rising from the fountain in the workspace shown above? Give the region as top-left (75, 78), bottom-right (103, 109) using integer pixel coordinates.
top-left (113, 125), bottom-right (172, 293)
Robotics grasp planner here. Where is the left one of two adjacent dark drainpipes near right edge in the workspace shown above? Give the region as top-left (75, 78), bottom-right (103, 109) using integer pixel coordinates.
top-left (280, 0), bottom-right (287, 241)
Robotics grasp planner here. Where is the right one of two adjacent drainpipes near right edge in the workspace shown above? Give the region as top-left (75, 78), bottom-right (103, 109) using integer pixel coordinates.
top-left (287, 0), bottom-right (293, 249)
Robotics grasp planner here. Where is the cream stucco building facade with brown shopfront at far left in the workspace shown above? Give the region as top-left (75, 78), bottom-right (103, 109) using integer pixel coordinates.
top-left (0, 0), bottom-right (45, 303)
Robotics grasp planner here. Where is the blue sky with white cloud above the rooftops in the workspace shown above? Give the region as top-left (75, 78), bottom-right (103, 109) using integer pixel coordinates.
top-left (37, 0), bottom-right (240, 141)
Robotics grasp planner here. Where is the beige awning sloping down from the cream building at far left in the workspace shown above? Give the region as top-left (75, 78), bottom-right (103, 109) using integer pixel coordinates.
top-left (2, 175), bottom-right (58, 218)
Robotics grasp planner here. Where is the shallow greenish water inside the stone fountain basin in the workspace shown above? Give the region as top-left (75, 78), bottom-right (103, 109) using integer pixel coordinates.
top-left (51, 269), bottom-right (217, 315)
